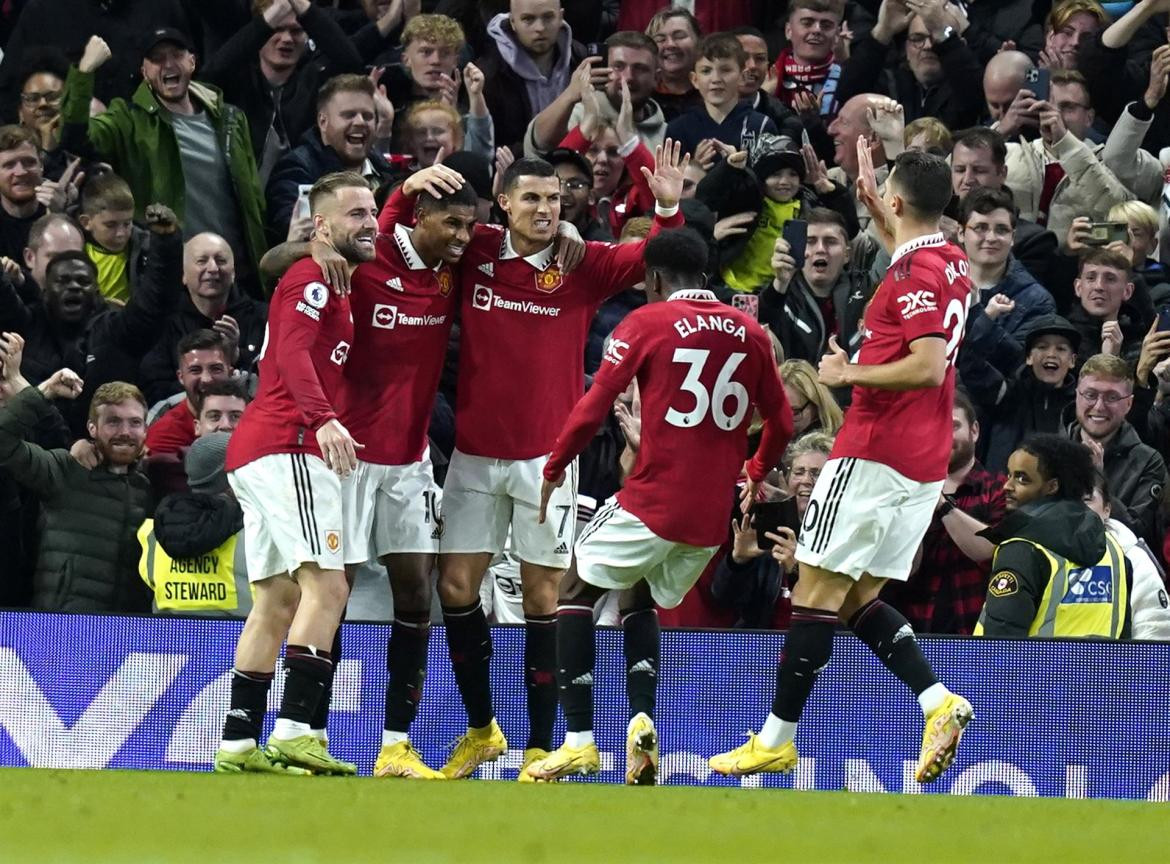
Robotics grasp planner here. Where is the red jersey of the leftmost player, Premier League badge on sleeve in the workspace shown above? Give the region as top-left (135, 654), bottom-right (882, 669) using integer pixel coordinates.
top-left (227, 258), bottom-right (353, 471)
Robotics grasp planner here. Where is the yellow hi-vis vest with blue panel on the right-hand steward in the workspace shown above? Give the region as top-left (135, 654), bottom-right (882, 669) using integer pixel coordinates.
top-left (1006, 534), bottom-right (1129, 639)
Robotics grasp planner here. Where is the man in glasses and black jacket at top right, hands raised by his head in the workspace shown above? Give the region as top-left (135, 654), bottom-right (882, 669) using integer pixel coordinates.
top-left (840, 0), bottom-right (983, 129)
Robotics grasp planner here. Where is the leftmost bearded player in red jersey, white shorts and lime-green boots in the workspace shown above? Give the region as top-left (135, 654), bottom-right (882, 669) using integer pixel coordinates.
top-left (214, 172), bottom-right (378, 774)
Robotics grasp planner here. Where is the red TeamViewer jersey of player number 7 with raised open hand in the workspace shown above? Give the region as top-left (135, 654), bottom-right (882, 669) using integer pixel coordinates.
top-left (378, 197), bottom-right (683, 459)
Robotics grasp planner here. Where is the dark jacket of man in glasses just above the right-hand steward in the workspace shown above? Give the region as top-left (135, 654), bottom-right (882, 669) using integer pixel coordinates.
top-left (1068, 423), bottom-right (1166, 549)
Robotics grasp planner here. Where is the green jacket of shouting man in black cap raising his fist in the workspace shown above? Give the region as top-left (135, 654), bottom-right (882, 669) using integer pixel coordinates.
top-left (61, 66), bottom-right (268, 272)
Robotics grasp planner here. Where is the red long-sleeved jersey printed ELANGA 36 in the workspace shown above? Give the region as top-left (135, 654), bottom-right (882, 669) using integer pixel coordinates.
top-left (545, 290), bottom-right (792, 546)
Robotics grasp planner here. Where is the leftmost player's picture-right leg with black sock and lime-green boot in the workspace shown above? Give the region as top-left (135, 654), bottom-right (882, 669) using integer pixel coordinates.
top-left (268, 562), bottom-right (357, 774)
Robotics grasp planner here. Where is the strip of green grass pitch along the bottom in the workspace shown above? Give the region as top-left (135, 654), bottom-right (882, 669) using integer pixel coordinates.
top-left (0, 769), bottom-right (1170, 864)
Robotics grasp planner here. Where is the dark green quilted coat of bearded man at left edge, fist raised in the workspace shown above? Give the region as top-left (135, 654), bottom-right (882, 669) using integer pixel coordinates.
top-left (0, 388), bottom-right (153, 612)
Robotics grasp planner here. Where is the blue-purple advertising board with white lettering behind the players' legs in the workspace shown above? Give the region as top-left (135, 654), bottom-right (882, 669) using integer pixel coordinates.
top-left (0, 612), bottom-right (1170, 801)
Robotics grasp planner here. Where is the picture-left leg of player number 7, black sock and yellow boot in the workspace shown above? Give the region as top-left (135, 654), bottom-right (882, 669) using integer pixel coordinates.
top-left (439, 553), bottom-right (508, 780)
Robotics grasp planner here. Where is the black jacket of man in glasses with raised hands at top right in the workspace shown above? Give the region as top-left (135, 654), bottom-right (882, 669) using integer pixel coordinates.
top-left (838, 35), bottom-right (984, 129)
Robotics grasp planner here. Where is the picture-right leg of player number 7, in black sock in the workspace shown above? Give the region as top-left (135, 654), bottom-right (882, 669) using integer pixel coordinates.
top-left (519, 561), bottom-right (565, 780)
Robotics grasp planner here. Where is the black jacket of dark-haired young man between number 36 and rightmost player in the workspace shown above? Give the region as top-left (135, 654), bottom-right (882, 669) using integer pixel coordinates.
top-left (759, 267), bottom-right (875, 365)
